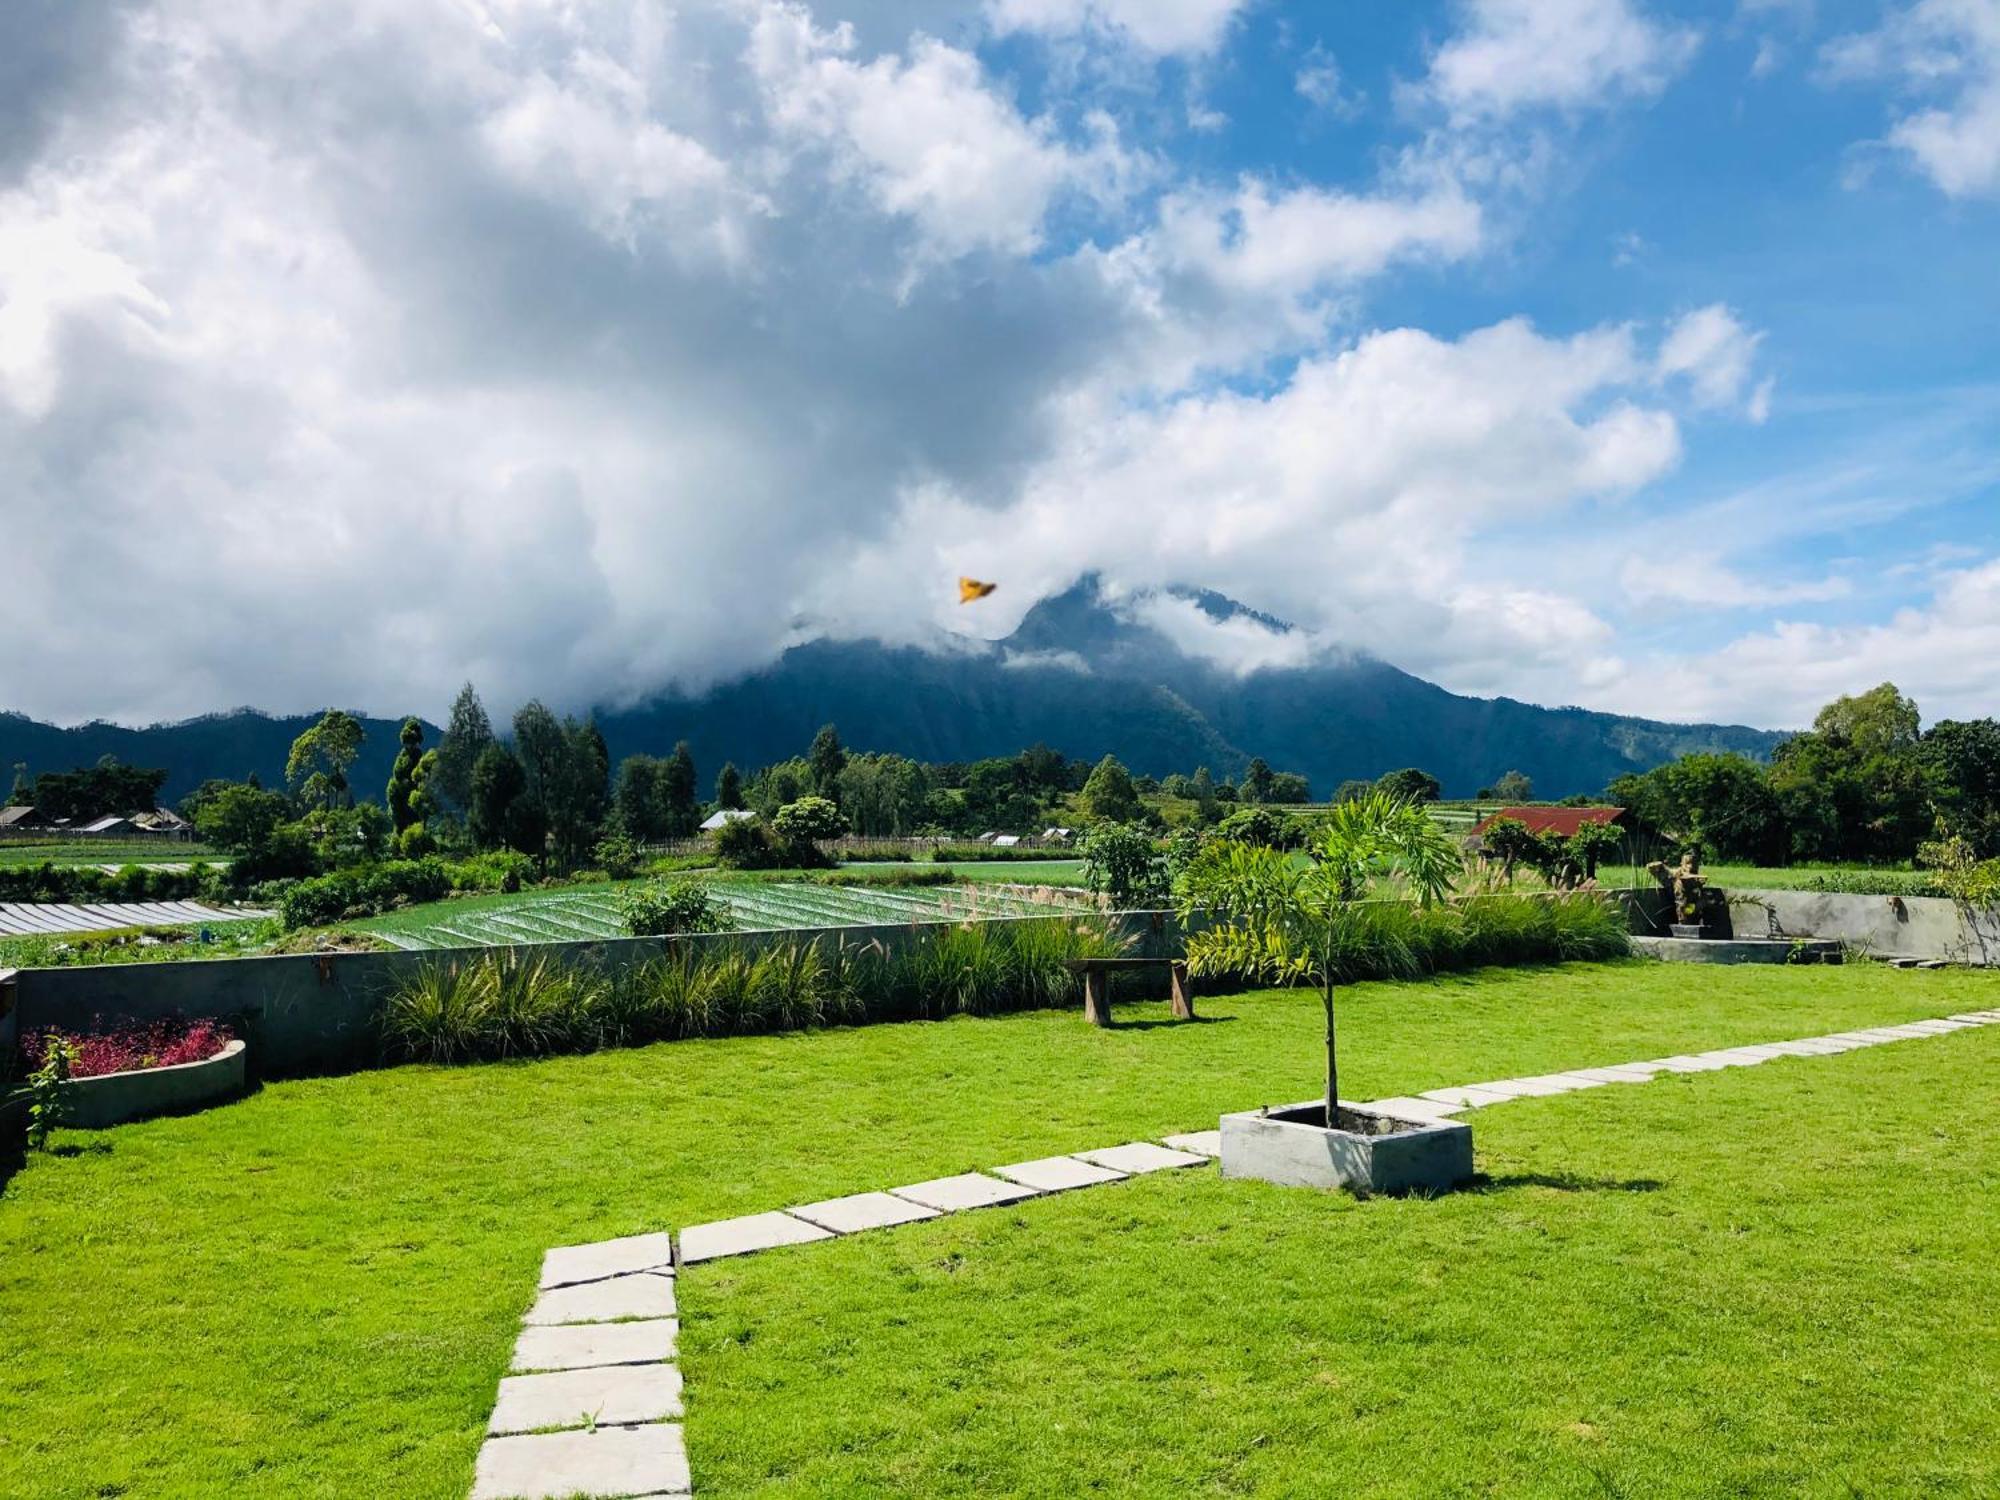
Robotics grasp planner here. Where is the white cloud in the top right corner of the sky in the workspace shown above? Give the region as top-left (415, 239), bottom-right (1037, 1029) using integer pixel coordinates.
top-left (1822, 0), bottom-right (2000, 198)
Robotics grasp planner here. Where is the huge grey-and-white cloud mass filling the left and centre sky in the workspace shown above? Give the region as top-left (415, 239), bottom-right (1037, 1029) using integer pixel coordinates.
top-left (0, 0), bottom-right (1800, 732)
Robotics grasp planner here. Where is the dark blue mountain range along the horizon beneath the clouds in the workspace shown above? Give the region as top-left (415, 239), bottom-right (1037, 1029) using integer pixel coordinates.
top-left (0, 578), bottom-right (1784, 798)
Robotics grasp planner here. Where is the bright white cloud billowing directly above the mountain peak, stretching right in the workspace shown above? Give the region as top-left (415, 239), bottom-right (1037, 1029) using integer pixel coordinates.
top-left (822, 320), bottom-right (1680, 696)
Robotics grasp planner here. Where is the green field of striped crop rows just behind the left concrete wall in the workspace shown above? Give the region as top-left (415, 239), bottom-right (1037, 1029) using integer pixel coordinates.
top-left (354, 880), bottom-right (1080, 948)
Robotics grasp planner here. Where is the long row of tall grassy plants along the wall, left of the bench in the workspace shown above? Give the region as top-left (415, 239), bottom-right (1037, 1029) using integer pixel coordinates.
top-left (382, 918), bottom-right (1116, 1062)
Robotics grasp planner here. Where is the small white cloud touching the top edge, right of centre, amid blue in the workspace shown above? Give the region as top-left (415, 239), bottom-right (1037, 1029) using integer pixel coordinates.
top-left (1426, 0), bottom-right (1700, 120)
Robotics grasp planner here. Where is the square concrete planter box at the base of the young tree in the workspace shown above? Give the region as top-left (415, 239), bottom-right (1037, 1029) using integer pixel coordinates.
top-left (1222, 1100), bottom-right (1472, 1192)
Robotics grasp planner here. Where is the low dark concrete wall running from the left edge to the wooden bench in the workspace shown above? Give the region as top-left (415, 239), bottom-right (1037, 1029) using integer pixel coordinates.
top-left (0, 912), bottom-right (1180, 1076)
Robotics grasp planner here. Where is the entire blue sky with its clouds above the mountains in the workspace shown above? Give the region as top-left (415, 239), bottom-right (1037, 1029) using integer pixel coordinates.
top-left (0, 0), bottom-right (2000, 726)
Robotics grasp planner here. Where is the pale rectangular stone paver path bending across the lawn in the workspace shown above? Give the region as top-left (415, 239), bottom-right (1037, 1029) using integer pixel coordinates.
top-left (472, 1010), bottom-right (2000, 1500)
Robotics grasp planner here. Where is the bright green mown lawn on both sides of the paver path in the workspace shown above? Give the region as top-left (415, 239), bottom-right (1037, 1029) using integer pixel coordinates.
top-left (0, 962), bottom-right (2000, 1500)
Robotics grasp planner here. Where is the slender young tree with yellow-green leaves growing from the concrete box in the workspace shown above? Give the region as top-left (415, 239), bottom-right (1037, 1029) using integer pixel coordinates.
top-left (1182, 792), bottom-right (1464, 1130)
